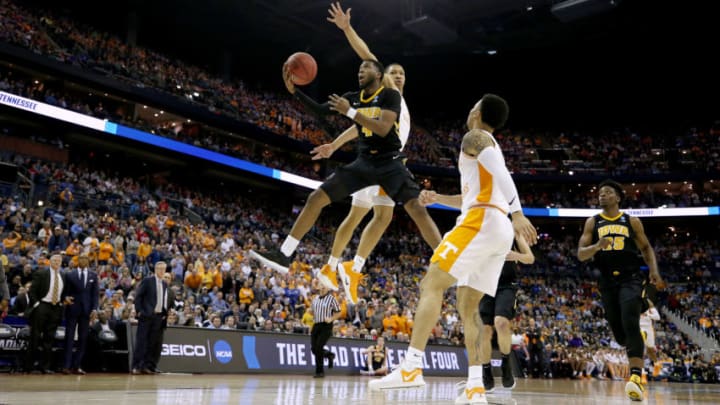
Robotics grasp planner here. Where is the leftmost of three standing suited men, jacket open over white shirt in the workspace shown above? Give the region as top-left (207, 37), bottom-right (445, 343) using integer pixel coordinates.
top-left (25, 255), bottom-right (72, 374)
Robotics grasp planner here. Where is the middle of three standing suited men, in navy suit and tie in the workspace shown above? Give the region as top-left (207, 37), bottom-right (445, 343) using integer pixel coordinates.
top-left (63, 255), bottom-right (98, 375)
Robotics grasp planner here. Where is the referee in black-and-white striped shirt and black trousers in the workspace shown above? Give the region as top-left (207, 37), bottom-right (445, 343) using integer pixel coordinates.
top-left (310, 283), bottom-right (340, 378)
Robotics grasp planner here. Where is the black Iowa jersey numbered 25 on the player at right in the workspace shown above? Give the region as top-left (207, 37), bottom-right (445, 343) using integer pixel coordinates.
top-left (592, 213), bottom-right (642, 276)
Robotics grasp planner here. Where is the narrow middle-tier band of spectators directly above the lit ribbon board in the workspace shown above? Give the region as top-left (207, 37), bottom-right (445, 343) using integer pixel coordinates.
top-left (5, 63), bottom-right (720, 208)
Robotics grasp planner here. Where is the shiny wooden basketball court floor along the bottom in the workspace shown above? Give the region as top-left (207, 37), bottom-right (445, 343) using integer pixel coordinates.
top-left (0, 374), bottom-right (720, 405)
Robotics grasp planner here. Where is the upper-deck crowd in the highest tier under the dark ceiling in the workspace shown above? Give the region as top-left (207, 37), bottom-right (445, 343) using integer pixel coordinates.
top-left (0, 0), bottom-right (720, 175)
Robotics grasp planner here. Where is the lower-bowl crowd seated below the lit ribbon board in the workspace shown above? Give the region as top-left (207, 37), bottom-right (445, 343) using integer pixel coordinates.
top-left (0, 150), bottom-right (720, 381)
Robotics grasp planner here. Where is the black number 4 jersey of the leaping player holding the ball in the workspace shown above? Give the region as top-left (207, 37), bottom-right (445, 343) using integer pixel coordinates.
top-left (343, 86), bottom-right (402, 156)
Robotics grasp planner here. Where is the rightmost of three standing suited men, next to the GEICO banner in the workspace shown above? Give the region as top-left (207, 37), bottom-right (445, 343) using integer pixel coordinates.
top-left (131, 262), bottom-right (169, 375)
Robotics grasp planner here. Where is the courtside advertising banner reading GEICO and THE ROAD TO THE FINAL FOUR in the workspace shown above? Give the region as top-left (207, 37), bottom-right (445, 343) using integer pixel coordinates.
top-left (128, 326), bottom-right (468, 377)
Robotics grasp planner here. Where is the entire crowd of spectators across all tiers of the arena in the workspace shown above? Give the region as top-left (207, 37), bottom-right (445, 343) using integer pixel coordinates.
top-left (0, 0), bottom-right (720, 382)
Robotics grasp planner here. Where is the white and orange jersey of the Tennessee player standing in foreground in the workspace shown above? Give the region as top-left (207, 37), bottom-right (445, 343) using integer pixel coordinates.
top-left (457, 131), bottom-right (510, 224)
